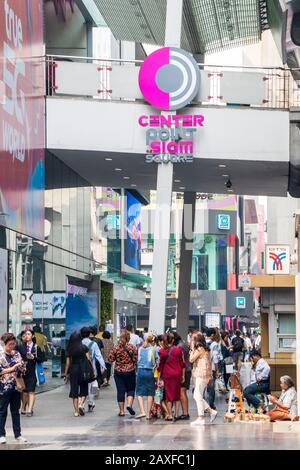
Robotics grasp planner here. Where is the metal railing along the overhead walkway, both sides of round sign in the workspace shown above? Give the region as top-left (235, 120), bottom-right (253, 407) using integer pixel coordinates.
top-left (46, 56), bottom-right (300, 109)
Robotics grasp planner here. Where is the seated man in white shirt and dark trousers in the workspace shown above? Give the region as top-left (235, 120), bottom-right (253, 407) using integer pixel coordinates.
top-left (244, 350), bottom-right (271, 408)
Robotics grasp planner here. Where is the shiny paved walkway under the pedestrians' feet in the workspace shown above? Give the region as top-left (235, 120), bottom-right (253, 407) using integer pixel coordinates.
top-left (1, 386), bottom-right (300, 450)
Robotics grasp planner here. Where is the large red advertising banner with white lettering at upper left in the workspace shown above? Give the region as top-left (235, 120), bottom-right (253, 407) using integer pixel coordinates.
top-left (0, 0), bottom-right (45, 239)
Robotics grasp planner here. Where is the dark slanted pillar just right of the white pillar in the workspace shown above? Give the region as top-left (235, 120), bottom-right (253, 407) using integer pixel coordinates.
top-left (177, 192), bottom-right (196, 339)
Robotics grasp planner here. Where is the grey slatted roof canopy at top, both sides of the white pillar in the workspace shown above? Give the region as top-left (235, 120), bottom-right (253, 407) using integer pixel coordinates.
top-left (93, 0), bottom-right (267, 54)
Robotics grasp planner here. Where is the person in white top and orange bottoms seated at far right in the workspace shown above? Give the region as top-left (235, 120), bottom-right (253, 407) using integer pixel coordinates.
top-left (268, 375), bottom-right (299, 421)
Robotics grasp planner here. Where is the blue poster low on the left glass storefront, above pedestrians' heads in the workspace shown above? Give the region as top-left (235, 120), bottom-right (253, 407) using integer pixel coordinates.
top-left (66, 284), bottom-right (98, 339)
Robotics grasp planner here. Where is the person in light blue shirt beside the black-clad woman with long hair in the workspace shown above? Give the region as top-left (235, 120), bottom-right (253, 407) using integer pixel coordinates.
top-left (80, 327), bottom-right (106, 413)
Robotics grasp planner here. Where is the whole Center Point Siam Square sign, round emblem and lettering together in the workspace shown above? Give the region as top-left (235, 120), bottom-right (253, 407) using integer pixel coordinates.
top-left (139, 47), bottom-right (204, 163)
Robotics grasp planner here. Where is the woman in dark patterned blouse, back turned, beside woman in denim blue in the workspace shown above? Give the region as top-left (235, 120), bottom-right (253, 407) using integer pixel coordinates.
top-left (108, 331), bottom-right (137, 417)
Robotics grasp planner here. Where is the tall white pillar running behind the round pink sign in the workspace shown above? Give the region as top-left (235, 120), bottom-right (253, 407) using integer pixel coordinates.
top-left (149, 0), bottom-right (183, 333)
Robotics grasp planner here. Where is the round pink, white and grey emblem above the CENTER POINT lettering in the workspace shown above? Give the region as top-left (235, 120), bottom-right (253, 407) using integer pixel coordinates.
top-left (139, 47), bottom-right (201, 111)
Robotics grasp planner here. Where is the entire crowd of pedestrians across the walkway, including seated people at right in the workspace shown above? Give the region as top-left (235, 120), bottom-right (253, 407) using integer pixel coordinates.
top-left (0, 325), bottom-right (298, 444)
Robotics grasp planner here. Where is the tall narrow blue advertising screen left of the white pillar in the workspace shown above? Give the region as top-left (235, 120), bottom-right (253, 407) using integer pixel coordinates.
top-left (123, 191), bottom-right (142, 272)
